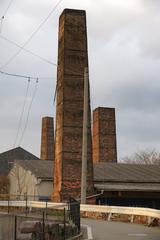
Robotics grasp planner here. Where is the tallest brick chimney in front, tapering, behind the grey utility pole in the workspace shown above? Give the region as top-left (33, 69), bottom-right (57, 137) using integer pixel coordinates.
top-left (53, 9), bottom-right (93, 201)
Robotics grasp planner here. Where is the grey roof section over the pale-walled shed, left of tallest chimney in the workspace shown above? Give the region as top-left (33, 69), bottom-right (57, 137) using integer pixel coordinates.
top-left (16, 160), bottom-right (53, 179)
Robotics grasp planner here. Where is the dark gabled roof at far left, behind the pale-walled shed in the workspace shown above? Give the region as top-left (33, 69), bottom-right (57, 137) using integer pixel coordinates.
top-left (0, 147), bottom-right (39, 175)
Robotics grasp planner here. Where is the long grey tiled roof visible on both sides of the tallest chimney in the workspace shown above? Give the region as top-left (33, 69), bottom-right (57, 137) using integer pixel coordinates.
top-left (14, 160), bottom-right (160, 188)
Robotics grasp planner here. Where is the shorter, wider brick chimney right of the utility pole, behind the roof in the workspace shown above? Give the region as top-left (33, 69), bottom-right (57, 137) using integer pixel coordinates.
top-left (93, 107), bottom-right (117, 163)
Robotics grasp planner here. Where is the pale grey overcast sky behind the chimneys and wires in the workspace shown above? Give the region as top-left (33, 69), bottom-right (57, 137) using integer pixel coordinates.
top-left (0, 0), bottom-right (160, 159)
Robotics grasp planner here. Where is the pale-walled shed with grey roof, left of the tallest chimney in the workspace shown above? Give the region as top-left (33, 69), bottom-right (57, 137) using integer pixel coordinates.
top-left (9, 160), bottom-right (53, 200)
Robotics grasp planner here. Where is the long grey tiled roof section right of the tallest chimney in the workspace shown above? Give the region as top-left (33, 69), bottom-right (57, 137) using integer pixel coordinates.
top-left (94, 163), bottom-right (160, 183)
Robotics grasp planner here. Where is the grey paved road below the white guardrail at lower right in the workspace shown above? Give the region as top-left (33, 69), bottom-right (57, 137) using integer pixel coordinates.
top-left (82, 219), bottom-right (160, 240)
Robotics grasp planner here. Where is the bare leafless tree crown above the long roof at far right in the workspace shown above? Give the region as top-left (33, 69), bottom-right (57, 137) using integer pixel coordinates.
top-left (122, 149), bottom-right (160, 165)
